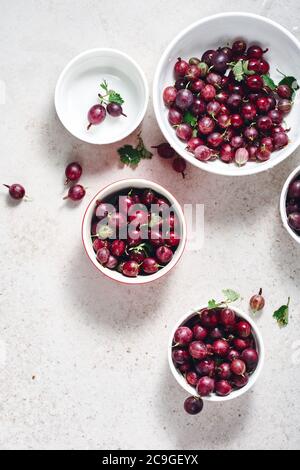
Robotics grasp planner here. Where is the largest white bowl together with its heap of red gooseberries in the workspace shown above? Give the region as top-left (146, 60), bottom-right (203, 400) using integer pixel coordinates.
top-left (153, 13), bottom-right (300, 176)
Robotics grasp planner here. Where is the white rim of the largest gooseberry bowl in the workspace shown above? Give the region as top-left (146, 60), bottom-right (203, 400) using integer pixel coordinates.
top-left (152, 11), bottom-right (300, 176)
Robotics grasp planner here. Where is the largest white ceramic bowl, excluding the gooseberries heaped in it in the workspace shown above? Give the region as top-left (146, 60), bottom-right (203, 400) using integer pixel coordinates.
top-left (153, 13), bottom-right (300, 176)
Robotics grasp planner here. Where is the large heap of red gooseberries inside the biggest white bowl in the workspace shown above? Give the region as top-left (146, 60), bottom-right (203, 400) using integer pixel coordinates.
top-left (163, 40), bottom-right (294, 166)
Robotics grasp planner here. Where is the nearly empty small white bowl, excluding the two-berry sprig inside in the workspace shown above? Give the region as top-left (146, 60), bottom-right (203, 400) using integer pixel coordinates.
top-left (55, 49), bottom-right (149, 144)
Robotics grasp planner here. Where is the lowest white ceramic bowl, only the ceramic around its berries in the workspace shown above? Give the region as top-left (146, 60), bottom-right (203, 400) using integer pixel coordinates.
top-left (168, 305), bottom-right (265, 402)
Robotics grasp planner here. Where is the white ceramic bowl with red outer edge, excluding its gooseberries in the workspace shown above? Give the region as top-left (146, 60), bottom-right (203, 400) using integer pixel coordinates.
top-left (82, 179), bottom-right (187, 284)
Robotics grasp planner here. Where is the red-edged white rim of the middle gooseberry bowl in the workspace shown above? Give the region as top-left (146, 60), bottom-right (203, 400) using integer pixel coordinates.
top-left (81, 178), bottom-right (187, 286)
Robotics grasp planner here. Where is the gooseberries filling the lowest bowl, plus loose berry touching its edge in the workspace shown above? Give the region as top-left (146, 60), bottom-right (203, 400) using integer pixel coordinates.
top-left (172, 307), bottom-right (259, 414)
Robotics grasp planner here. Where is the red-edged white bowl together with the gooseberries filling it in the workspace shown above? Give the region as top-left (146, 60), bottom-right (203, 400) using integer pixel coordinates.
top-left (82, 179), bottom-right (187, 284)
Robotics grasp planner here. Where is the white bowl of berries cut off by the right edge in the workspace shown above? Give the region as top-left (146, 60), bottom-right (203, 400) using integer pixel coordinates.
top-left (280, 166), bottom-right (300, 243)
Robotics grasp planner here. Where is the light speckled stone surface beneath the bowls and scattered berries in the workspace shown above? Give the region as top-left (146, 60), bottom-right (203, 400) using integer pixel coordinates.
top-left (0, 0), bottom-right (300, 449)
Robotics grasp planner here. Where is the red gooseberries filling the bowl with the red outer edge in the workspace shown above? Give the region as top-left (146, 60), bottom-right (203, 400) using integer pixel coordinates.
top-left (91, 188), bottom-right (181, 277)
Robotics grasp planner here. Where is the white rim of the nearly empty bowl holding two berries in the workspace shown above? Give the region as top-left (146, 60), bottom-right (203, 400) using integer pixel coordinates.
top-left (54, 47), bottom-right (149, 145)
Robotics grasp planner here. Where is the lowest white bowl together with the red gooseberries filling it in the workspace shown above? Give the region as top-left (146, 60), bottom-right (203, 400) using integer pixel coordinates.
top-left (168, 305), bottom-right (265, 408)
